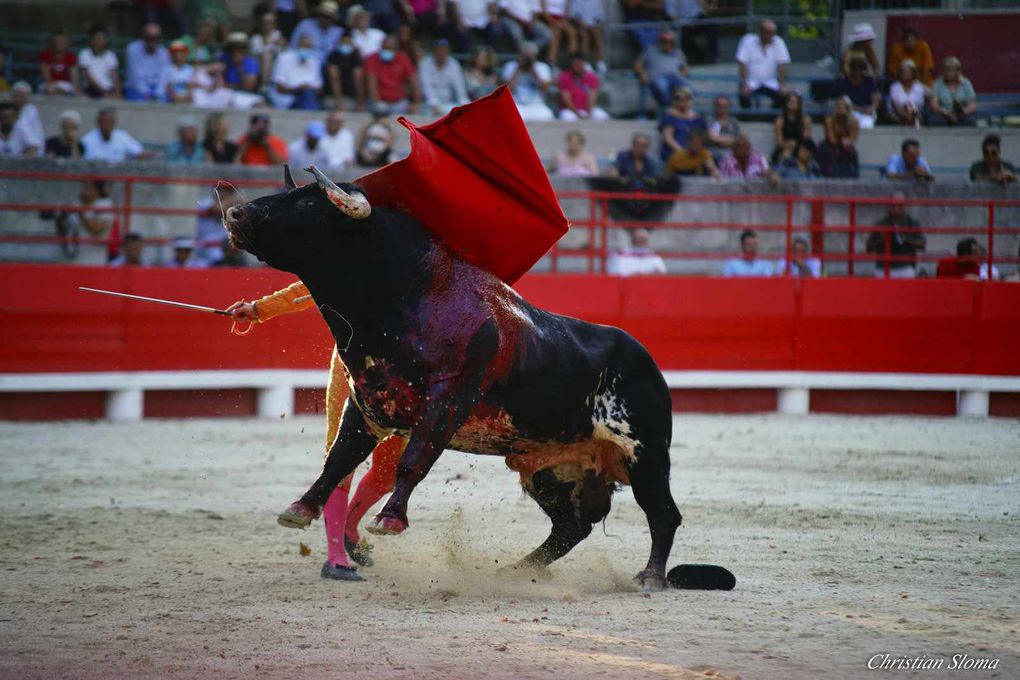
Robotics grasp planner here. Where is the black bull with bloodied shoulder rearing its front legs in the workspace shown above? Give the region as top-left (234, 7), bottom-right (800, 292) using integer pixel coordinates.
top-left (224, 168), bottom-right (680, 588)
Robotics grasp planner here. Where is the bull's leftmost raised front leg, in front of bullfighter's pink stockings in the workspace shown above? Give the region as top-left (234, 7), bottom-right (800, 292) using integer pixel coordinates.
top-left (276, 400), bottom-right (376, 529)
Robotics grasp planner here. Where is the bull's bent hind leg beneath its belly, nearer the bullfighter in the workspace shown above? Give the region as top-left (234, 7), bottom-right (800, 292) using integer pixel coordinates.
top-left (516, 466), bottom-right (612, 569)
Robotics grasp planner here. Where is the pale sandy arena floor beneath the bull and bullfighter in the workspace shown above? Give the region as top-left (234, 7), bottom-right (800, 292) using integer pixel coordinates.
top-left (0, 416), bottom-right (1020, 680)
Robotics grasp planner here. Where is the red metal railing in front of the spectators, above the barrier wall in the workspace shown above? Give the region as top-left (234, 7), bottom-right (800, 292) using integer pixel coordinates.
top-left (0, 171), bottom-right (1020, 276)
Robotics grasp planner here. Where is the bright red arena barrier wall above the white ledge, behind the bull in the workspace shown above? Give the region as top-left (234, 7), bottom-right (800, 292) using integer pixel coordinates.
top-left (0, 264), bottom-right (1020, 375)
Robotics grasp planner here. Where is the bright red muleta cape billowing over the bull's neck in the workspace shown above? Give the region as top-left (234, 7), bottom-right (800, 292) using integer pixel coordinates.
top-left (356, 86), bottom-right (569, 285)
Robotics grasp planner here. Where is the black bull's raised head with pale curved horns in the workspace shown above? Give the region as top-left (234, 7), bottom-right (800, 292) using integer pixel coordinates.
top-left (223, 165), bottom-right (372, 275)
